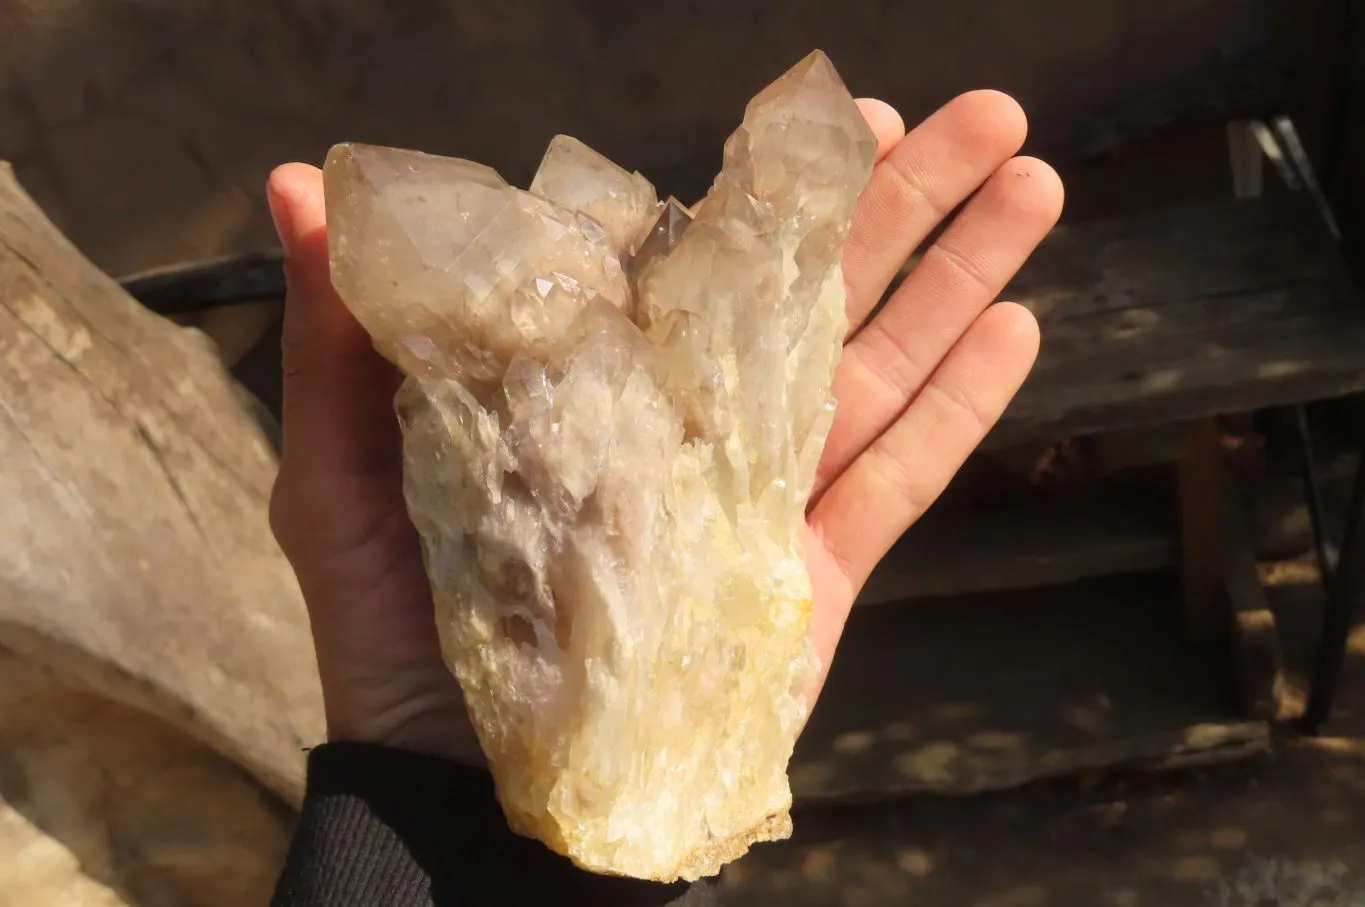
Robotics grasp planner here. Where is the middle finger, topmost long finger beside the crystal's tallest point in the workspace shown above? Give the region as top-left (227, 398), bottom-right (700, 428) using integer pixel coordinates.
top-left (844, 92), bottom-right (1028, 331)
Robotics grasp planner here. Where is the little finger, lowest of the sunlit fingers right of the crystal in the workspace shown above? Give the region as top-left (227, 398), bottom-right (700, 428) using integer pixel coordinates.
top-left (809, 303), bottom-right (1039, 611)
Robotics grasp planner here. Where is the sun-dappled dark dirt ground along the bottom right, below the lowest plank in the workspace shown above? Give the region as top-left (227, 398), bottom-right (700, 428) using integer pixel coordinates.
top-left (715, 573), bottom-right (1365, 907)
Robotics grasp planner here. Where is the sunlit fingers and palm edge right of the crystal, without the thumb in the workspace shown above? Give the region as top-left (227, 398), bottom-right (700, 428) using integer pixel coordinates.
top-left (807, 92), bottom-right (1063, 693)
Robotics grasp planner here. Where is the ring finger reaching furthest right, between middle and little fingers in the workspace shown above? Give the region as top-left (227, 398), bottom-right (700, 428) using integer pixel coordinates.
top-left (815, 157), bottom-right (1063, 494)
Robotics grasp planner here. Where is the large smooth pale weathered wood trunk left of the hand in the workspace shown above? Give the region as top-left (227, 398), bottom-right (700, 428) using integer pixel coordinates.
top-left (0, 164), bottom-right (322, 799)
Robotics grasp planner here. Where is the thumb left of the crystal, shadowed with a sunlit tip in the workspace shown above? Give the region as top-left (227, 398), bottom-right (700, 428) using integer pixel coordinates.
top-left (266, 164), bottom-right (400, 477)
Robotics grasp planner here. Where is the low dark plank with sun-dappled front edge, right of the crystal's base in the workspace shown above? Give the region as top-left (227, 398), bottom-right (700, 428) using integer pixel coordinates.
top-left (790, 576), bottom-right (1269, 802)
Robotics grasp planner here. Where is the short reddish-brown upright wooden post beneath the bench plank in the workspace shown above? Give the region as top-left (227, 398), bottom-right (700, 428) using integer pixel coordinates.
top-left (1177, 417), bottom-right (1223, 639)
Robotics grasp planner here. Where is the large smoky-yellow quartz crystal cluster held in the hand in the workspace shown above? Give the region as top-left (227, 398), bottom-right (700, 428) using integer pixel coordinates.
top-left (325, 52), bottom-right (876, 880)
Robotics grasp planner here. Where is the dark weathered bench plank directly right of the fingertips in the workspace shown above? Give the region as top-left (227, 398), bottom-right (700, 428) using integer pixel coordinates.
top-left (988, 198), bottom-right (1365, 445)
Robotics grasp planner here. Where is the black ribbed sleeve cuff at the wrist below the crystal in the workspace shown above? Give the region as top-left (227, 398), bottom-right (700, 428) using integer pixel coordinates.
top-left (270, 743), bottom-right (719, 907)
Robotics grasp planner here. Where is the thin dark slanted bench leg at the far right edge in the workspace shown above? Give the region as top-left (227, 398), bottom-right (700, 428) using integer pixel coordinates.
top-left (1304, 451), bottom-right (1365, 734)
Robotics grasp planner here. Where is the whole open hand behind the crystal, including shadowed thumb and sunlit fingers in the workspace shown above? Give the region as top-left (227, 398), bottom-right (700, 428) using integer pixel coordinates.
top-left (268, 92), bottom-right (1062, 759)
